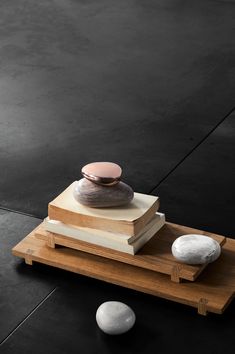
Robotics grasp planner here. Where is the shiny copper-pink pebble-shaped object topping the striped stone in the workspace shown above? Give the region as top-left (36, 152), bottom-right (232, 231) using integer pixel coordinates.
top-left (82, 162), bottom-right (122, 185)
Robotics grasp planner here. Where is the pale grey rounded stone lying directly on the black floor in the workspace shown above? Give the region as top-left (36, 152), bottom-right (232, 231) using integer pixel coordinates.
top-left (96, 301), bottom-right (136, 334)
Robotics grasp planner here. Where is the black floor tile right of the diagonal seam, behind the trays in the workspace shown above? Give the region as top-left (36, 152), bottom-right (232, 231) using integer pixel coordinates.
top-left (153, 113), bottom-right (235, 238)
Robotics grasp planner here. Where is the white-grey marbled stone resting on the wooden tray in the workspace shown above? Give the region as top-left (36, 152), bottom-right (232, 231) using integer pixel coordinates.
top-left (171, 234), bottom-right (221, 264)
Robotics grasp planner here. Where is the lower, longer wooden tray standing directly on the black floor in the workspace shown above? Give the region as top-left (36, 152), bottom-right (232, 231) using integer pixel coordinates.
top-left (13, 226), bottom-right (235, 315)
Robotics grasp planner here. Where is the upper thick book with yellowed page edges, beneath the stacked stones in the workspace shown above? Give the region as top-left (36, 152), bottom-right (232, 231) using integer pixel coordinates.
top-left (48, 182), bottom-right (159, 236)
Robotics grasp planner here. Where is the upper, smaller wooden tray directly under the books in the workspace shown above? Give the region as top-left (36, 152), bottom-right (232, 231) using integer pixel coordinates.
top-left (35, 223), bottom-right (226, 282)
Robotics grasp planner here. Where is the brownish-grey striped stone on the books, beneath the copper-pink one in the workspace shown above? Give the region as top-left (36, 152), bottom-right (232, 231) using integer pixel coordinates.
top-left (73, 178), bottom-right (134, 208)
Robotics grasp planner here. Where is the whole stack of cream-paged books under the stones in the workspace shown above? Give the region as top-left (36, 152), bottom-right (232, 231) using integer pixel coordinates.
top-left (37, 182), bottom-right (165, 255)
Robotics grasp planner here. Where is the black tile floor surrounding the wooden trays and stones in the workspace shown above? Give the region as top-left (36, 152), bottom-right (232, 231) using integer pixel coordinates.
top-left (0, 0), bottom-right (235, 354)
